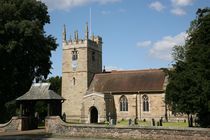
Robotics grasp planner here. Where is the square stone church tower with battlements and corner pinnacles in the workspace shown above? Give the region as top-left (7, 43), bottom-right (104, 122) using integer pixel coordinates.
top-left (62, 23), bottom-right (102, 121)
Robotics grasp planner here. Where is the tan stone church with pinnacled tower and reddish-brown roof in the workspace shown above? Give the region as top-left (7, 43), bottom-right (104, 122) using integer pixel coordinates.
top-left (62, 24), bottom-right (167, 123)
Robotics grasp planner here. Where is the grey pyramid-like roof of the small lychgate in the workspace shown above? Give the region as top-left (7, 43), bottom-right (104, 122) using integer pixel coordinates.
top-left (16, 83), bottom-right (64, 101)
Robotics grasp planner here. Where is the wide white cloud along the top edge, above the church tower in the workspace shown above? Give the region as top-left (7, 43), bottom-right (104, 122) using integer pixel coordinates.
top-left (40, 0), bottom-right (121, 10)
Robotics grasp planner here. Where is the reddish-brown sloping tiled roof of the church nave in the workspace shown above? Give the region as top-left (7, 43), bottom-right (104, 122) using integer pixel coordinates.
top-left (87, 69), bottom-right (165, 94)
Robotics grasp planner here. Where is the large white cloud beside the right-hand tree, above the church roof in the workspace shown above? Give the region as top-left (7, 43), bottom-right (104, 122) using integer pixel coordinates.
top-left (149, 32), bottom-right (187, 60)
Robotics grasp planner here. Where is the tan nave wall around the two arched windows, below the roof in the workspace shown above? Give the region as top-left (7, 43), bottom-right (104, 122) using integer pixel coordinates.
top-left (114, 93), bottom-right (166, 121)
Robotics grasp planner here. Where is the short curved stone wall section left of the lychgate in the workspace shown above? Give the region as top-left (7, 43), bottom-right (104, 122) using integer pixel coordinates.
top-left (0, 116), bottom-right (28, 132)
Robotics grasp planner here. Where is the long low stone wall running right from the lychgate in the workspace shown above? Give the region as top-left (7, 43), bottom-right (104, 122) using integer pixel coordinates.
top-left (45, 116), bottom-right (210, 140)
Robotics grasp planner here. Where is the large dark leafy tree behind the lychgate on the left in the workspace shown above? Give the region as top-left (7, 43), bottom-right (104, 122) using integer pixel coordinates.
top-left (0, 0), bottom-right (57, 120)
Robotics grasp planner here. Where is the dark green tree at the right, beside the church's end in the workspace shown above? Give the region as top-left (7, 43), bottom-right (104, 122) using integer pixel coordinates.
top-left (166, 8), bottom-right (210, 127)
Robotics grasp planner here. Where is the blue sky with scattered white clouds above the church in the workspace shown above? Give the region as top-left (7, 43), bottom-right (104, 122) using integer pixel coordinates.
top-left (41, 0), bottom-right (210, 76)
